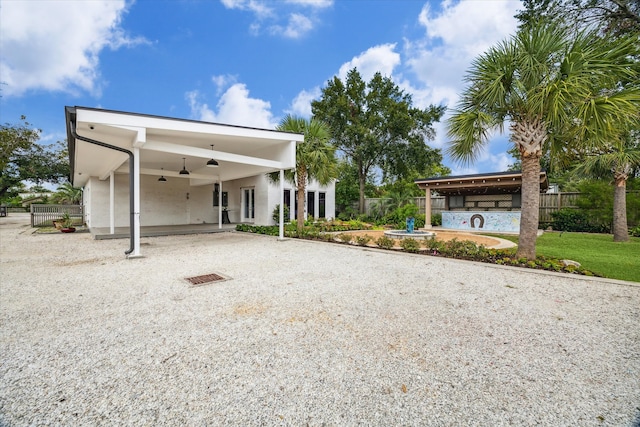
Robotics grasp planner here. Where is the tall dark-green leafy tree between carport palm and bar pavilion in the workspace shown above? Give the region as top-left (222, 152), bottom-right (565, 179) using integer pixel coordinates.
top-left (311, 68), bottom-right (445, 213)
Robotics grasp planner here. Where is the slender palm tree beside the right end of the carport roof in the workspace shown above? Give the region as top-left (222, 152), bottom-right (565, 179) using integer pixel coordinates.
top-left (269, 115), bottom-right (337, 232)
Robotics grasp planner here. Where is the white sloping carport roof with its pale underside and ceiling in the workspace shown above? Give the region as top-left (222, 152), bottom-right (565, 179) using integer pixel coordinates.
top-left (65, 107), bottom-right (303, 187)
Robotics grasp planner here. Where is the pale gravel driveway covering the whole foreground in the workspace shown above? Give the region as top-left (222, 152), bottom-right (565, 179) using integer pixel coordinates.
top-left (0, 216), bottom-right (640, 426)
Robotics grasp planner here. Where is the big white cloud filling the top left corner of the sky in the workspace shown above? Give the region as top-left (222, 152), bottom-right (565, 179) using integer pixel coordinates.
top-left (0, 0), bottom-right (148, 96)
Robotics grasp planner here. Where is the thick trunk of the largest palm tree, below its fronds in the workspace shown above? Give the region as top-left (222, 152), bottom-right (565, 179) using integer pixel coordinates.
top-left (516, 154), bottom-right (540, 260)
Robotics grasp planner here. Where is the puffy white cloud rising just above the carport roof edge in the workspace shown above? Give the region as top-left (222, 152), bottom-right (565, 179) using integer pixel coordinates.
top-left (185, 83), bottom-right (278, 129)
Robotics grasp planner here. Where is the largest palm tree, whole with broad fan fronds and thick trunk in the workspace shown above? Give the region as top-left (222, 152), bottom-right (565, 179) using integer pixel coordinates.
top-left (448, 23), bottom-right (640, 259)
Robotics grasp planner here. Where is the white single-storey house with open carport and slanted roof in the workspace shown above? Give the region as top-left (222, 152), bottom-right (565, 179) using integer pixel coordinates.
top-left (65, 107), bottom-right (335, 257)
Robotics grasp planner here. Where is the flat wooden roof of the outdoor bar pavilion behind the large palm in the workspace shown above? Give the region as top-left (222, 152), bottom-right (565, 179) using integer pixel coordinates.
top-left (414, 172), bottom-right (549, 196)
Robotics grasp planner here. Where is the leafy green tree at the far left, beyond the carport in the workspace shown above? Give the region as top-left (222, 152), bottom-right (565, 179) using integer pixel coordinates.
top-left (0, 116), bottom-right (69, 197)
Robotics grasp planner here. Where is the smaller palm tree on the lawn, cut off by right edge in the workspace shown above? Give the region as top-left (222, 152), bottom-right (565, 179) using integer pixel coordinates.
top-left (574, 132), bottom-right (640, 242)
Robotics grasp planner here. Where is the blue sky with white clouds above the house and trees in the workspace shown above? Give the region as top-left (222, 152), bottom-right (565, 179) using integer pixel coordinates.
top-left (0, 0), bottom-right (522, 178)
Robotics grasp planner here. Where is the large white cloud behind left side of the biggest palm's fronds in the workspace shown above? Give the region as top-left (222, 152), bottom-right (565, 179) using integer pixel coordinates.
top-left (403, 0), bottom-right (522, 167)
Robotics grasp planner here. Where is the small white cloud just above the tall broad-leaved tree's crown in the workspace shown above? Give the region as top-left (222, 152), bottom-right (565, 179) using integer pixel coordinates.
top-left (338, 43), bottom-right (400, 82)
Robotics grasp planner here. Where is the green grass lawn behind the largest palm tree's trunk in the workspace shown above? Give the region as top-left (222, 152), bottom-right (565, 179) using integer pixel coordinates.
top-left (500, 232), bottom-right (640, 282)
